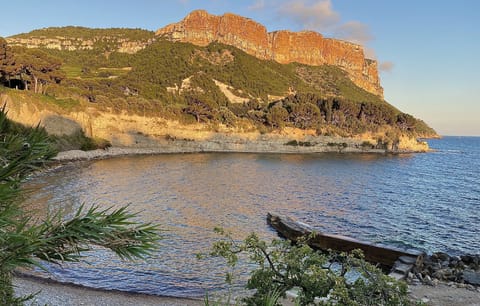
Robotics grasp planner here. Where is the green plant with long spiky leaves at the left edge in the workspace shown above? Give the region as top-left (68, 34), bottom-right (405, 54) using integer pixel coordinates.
top-left (0, 108), bottom-right (159, 305)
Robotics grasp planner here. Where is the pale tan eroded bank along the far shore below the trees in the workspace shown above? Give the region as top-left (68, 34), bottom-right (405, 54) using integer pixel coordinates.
top-left (0, 94), bottom-right (429, 159)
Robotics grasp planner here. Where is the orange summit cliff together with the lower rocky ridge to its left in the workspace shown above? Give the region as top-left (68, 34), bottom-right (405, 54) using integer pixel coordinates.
top-left (7, 10), bottom-right (383, 97)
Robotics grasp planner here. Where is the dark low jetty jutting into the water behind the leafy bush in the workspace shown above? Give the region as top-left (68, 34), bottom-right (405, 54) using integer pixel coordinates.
top-left (267, 213), bottom-right (425, 279)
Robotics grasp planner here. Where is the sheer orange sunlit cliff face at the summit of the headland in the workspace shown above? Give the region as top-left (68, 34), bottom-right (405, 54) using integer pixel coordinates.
top-left (156, 10), bottom-right (383, 96)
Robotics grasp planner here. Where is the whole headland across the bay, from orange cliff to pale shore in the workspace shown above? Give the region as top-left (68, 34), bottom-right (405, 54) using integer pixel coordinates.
top-left (0, 10), bottom-right (435, 156)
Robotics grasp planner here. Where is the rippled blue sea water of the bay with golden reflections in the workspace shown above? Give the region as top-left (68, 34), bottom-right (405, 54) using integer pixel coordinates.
top-left (22, 137), bottom-right (480, 296)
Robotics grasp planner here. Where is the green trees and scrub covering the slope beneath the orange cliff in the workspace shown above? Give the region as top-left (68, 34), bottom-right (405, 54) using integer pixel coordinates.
top-left (0, 27), bottom-right (436, 138)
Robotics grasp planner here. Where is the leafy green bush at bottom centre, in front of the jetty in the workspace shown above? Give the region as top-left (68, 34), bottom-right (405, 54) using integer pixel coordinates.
top-left (210, 228), bottom-right (415, 306)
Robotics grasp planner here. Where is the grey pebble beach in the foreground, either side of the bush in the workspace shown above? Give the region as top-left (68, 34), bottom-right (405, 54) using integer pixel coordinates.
top-left (13, 272), bottom-right (480, 306)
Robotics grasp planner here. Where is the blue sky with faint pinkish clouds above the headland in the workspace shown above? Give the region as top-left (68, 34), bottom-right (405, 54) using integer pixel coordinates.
top-left (0, 0), bottom-right (480, 136)
